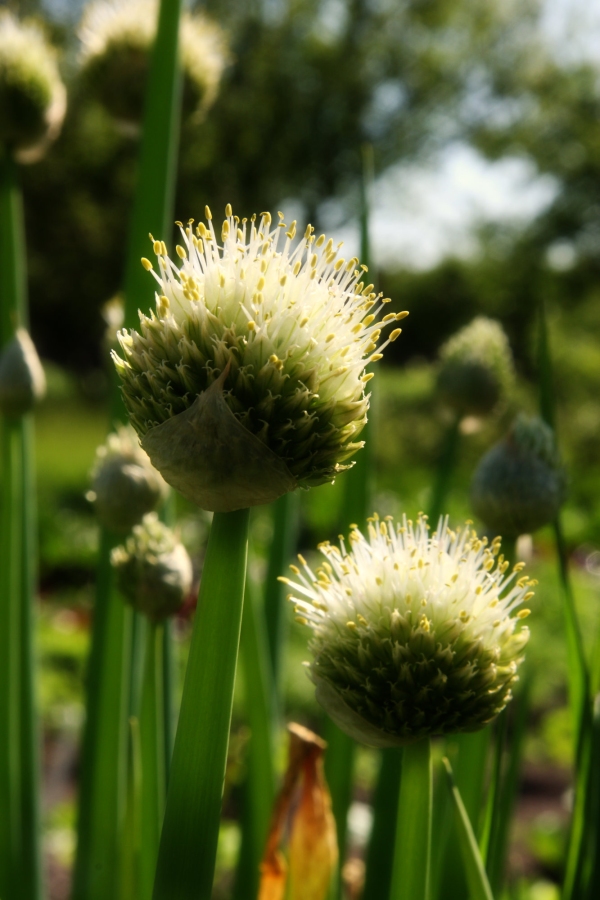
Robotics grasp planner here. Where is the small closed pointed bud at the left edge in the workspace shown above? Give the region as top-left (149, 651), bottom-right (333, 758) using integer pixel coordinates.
top-left (0, 328), bottom-right (46, 417)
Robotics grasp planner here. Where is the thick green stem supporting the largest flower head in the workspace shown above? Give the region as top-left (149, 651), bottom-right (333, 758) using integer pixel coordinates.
top-left (153, 510), bottom-right (248, 900)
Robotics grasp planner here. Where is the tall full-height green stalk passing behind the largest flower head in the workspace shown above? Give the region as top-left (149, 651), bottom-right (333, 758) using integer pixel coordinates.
top-left (73, 0), bottom-right (181, 888)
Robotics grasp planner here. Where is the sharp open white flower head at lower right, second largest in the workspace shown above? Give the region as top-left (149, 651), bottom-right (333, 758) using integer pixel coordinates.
top-left (282, 516), bottom-right (534, 747)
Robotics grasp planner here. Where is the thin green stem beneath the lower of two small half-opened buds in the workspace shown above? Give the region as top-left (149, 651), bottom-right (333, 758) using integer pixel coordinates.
top-left (140, 623), bottom-right (165, 900)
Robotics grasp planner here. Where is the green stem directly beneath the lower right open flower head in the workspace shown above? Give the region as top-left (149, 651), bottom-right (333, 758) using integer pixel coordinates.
top-left (390, 737), bottom-right (433, 900)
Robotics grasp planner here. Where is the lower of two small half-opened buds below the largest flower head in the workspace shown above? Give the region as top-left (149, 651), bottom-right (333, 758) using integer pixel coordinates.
top-left (111, 513), bottom-right (192, 622)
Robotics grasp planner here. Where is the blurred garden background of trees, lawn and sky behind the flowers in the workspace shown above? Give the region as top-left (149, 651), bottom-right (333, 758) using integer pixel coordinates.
top-left (8, 0), bottom-right (600, 900)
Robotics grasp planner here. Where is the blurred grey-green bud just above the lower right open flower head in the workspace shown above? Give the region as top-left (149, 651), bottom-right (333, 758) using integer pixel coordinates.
top-left (471, 415), bottom-right (565, 539)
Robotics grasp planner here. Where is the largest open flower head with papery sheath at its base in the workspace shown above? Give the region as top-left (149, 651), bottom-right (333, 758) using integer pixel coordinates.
top-left (113, 206), bottom-right (406, 511)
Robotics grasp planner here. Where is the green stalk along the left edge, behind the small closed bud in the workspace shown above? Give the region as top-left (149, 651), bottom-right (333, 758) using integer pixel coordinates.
top-left (0, 151), bottom-right (45, 900)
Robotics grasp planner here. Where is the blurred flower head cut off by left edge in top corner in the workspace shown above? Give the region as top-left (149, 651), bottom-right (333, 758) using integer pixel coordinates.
top-left (0, 10), bottom-right (66, 162)
